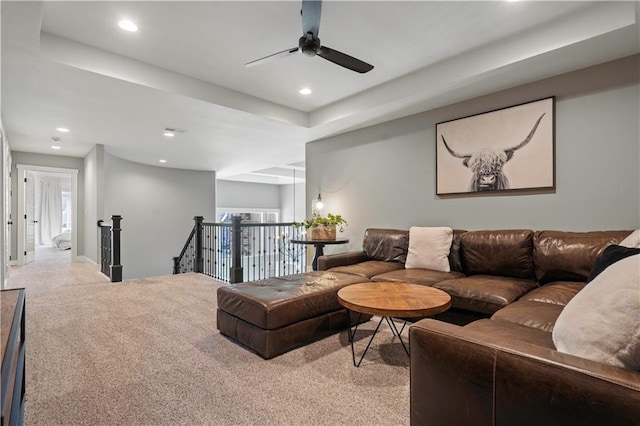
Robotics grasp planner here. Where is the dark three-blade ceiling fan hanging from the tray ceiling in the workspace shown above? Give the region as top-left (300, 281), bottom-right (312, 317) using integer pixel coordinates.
top-left (245, 0), bottom-right (373, 74)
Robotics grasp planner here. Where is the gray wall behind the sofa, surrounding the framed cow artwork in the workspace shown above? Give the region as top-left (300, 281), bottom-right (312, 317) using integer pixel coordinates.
top-left (306, 56), bottom-right (640, 251)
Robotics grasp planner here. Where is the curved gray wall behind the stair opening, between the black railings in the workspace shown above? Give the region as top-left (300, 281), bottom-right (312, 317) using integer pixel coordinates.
top-left (102, 153), bottom-right (215, 279)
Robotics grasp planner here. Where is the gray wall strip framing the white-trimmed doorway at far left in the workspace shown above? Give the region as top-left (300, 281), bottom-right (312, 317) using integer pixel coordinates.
top-left (11, 151), bottom-right (85, 260)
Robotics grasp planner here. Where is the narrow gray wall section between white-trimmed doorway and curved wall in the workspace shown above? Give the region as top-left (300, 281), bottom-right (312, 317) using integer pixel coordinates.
top-left (84, 145), bottom-right (109, 263)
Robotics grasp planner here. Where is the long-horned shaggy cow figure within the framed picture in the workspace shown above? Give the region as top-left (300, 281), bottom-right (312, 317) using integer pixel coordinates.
top-left (441, 113), bottom-right (546, 192)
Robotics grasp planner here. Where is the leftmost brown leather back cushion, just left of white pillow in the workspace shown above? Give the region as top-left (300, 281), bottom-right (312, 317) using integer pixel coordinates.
top-left (362, 228), bottom-right (409, 264)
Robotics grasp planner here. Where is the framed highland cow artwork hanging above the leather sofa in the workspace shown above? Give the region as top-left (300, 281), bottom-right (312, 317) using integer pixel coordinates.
top-left (436, 97), bottom-right (555, 195)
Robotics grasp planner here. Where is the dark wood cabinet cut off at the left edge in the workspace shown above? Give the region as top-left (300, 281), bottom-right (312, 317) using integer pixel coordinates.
top-left (0, 288), bottom-right (25, 426)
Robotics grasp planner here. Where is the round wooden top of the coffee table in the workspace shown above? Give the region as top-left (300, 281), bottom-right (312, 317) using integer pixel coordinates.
top-left (338, 282), bottom-right (451, 318)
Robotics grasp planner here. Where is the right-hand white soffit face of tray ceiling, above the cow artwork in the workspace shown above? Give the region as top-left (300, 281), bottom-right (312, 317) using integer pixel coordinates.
top-left (309, 3), bottom-right (640, 133)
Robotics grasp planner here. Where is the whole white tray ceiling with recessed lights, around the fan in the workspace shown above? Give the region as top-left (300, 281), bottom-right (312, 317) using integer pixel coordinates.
top-left (1, 1), bottom-right (640, 183)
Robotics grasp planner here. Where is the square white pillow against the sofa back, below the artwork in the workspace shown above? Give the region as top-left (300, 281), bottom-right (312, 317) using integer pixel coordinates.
top-left (404, 226), bottom-right (453, 272)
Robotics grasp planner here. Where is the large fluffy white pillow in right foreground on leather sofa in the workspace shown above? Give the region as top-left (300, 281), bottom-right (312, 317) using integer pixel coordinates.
top-left (553, 254), bottom-right (640, 370)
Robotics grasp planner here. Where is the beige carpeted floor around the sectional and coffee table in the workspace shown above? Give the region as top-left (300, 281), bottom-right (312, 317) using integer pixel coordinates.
top-left (9, 262), bottom-right (409, 425)
